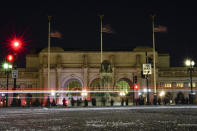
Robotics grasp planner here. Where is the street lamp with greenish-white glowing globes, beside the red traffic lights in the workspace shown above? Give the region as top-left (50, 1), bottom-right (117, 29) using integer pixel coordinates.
top-left (3, 63), bottom-right (12, 107)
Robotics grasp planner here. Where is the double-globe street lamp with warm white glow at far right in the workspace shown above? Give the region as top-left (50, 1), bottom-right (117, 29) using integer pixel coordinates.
top-left (185, 59), bottom-right (195, 104)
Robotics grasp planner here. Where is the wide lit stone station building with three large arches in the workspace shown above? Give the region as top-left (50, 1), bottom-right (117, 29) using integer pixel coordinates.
top-left (0, 47), bottom-right (197, 106)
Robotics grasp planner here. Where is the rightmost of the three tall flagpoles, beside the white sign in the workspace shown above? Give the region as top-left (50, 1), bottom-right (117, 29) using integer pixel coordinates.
top-left (152, 15), bottom-right (157, 99)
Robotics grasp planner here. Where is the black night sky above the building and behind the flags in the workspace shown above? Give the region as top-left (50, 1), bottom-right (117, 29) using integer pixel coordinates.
top-left (0, 0), bottom-right (197, 66)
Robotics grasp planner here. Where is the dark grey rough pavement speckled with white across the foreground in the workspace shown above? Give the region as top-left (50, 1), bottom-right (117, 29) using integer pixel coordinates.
top-left (0, 106), bottom-right (197, 131)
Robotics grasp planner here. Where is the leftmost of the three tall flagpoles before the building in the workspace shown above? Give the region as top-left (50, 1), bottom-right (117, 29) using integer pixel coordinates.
top-left (48, 16), bottom-right (51, 89)
